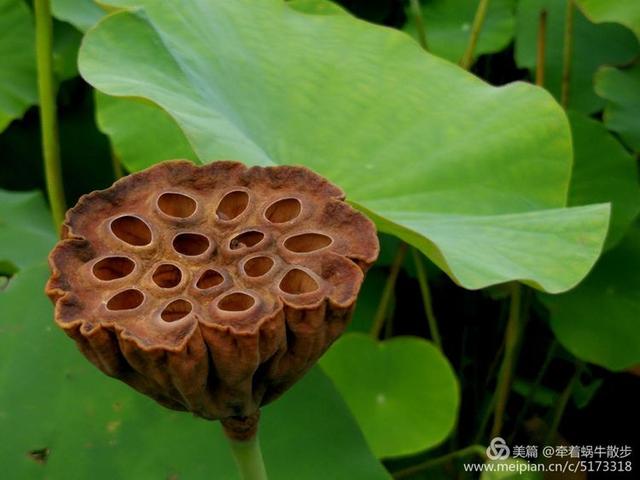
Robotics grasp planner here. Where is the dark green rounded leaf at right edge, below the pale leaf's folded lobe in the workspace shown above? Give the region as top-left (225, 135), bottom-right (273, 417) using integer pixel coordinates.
top-left (541, 225), bottom-right (640, 370)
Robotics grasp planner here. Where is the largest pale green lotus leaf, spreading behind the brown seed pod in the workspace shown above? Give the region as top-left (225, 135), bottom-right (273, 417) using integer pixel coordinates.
top-left (80, 0), bottom-right (608, 292)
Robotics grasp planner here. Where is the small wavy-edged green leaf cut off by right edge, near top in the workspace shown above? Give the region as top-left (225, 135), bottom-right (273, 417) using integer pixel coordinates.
top-left (596, 64), bottom-right (640, 152)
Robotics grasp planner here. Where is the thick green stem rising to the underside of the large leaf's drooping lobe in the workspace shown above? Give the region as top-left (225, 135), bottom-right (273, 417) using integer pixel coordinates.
top-left (491, 282), bottom-right (522, 437)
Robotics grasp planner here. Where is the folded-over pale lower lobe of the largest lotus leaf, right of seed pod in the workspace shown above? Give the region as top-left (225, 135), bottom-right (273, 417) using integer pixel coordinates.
top-left (365, 204), bottom-right (610, 293)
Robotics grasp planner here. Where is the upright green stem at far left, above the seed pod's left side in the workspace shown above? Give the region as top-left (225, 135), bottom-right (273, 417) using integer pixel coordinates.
top-left (33, 0), bottom-right (67, 230)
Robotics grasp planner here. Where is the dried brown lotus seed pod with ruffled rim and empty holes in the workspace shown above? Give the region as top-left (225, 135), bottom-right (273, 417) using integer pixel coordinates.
top-left (47, 161), bottom-right (378, 419)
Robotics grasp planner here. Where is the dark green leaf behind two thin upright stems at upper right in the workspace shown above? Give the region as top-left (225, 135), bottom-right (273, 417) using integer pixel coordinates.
top-left (516, 0), bottom-right (638, 114)
